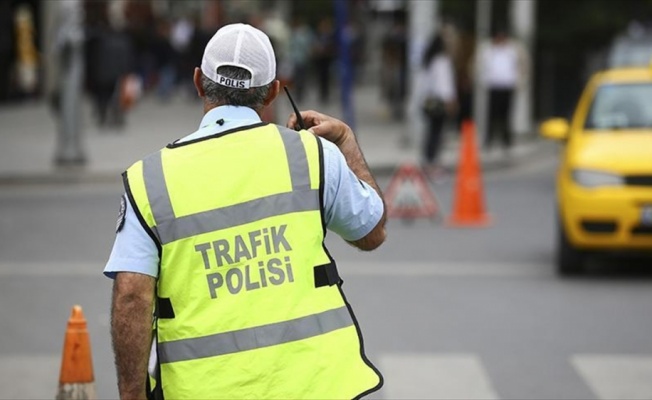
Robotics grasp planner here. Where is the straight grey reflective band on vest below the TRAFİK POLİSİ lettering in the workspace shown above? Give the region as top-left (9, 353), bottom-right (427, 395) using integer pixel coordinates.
top-left (159, 307), bottom-right (353, 364)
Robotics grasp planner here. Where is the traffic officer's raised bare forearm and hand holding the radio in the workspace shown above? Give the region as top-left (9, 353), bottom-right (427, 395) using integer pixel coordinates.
top-left (287, 111), bottom-right (387, 251)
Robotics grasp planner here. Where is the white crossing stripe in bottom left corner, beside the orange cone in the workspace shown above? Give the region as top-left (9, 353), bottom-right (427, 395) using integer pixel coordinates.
top-left (0, 355), bottom-right (61, 400)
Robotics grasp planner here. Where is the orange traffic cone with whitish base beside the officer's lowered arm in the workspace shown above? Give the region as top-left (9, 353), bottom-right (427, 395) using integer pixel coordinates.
top-left (56, 306), bottom-right (97, 400)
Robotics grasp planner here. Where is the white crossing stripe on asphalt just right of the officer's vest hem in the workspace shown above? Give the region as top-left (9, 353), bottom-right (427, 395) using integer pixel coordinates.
top-left (380, 353), bottom-right (498, 400)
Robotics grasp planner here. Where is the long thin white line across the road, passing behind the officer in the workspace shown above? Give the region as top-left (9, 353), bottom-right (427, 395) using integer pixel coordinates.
top-left (0, 260), bottom-right (553, 278)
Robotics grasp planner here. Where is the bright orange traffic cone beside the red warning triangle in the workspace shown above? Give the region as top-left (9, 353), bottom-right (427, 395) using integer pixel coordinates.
top-left (448, 120), bottom-right (490, 226)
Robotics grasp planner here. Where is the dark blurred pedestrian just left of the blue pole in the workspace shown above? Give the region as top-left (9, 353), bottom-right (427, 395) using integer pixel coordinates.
top-left (313, 17), bottom-right (337, 104)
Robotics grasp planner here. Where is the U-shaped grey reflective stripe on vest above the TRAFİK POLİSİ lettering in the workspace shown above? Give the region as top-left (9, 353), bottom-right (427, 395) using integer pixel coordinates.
top-left (143, 129), bottom-right (320, 244)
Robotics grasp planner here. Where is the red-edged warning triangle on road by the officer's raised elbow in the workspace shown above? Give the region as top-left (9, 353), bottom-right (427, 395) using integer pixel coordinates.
top-left (385, 164), bottom-right (439, 218)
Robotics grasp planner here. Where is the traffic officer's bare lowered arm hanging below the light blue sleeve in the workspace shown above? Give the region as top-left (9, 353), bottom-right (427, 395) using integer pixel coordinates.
top-left (111, 272), bottom-right (156, 400)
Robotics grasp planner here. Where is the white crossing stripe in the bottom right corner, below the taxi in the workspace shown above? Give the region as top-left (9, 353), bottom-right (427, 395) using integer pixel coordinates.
top-left (571, 354), bottom-right (652, 400)
